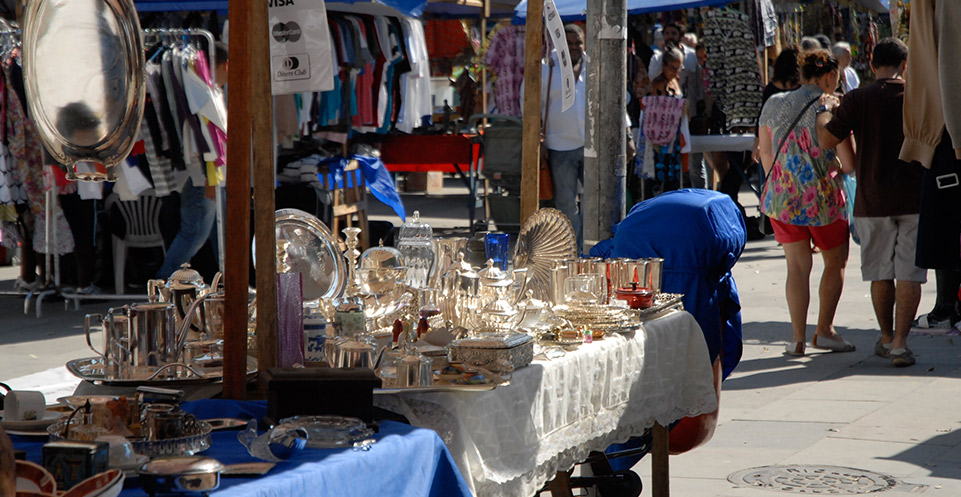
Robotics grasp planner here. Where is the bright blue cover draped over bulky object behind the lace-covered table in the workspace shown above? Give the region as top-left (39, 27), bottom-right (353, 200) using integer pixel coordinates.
top-left (591, 189), bottom-right (747, 378)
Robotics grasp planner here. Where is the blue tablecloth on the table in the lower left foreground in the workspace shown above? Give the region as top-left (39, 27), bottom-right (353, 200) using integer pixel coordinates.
top-left (11, 400), bottom-right (470, 497)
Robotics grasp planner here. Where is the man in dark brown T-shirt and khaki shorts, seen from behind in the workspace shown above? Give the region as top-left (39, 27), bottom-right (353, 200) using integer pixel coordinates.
top-left (817, 38), bottom-right (927, 366)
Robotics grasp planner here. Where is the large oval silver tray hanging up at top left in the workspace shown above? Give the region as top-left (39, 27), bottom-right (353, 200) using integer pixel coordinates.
top-left (23, 0), bottom-right (146, 181)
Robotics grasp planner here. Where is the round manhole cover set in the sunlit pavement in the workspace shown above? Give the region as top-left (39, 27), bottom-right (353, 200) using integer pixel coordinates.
top-left (727, 465), bottom-right (897, 495)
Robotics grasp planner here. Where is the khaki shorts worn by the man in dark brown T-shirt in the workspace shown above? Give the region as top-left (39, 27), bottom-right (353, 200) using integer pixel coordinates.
top-left (854, 214), bottom-right (928, 283)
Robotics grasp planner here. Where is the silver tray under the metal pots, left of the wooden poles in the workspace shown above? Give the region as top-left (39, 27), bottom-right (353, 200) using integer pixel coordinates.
top-left (66, 357), bottom-right (257, 387)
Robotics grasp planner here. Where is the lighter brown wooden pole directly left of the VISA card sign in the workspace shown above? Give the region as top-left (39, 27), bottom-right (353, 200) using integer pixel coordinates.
top-left (250, 0), bottom-right (277, 380)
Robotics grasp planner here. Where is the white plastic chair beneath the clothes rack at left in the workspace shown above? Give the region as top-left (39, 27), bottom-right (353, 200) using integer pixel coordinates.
top-left (106, 190), bottom-right (167, 294)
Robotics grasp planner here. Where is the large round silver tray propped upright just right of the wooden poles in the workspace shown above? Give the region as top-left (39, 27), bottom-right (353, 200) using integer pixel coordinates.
top-left (253, 209), bottom-right (348, 302)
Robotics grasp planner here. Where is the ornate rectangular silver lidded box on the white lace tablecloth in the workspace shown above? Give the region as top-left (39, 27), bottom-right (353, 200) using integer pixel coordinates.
top-left (449, 333), bottom-right (534, 373)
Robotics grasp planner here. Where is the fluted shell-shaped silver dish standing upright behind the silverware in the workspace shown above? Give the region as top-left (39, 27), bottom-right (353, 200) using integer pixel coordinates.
top-left (514, 209), bottom-right (577, 301)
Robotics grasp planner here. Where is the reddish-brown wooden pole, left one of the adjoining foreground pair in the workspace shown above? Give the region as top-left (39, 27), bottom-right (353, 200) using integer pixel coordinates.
top-left (223, 0), bottom-right (253, 399)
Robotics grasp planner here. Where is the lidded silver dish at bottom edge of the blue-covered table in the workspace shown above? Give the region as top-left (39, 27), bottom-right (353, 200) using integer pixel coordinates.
top-left (140, 456), bottom-right (224, 496)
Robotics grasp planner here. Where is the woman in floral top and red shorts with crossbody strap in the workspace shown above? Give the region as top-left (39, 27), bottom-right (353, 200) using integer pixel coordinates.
top-left (758, 50), bottom-right (854, 355)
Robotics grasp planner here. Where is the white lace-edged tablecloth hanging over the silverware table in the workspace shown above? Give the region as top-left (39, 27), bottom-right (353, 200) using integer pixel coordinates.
top-left (374, 311), bottom-right (717, 497)
